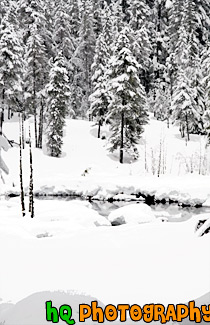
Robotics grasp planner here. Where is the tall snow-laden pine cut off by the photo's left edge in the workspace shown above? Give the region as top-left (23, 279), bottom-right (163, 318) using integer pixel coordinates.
top-left (0, 19), bottom-right (23, 134)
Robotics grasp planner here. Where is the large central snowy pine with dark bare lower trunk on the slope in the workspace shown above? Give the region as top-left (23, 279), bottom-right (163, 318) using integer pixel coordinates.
top-left (108, 27), bottom-right (148, 163)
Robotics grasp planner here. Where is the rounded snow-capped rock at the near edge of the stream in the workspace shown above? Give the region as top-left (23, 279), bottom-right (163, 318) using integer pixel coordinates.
top-left (108, 203), bottom-right (156, 225)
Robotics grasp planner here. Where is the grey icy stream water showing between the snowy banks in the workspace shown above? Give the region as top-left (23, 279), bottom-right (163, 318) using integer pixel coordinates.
top-left (35, 197), bottom-right (210, 222)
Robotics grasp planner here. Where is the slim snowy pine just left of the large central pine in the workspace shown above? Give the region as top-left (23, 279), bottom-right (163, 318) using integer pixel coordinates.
top-left (88, 34), bottom-right (109, 138)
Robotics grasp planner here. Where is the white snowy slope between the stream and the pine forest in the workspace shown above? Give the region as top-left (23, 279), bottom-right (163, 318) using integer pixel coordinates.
top-left (0, 117), bottom-right (210, 206)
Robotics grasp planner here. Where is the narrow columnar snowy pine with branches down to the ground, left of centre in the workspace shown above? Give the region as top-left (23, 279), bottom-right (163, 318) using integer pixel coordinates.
top-left (46, 52), bottom-right (70, 157)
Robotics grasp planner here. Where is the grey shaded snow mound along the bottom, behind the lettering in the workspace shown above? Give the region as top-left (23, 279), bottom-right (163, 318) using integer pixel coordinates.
top-left (0, 291), bottom-right (210, 325)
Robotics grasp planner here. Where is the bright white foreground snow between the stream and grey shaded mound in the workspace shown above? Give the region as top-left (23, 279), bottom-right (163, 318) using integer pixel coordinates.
top-left (0, 197), bottom-right (210, 304)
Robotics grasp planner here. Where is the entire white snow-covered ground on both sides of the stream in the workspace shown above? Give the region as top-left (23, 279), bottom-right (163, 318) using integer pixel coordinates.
top-left (0, 114), bottom-right (210, 325)
